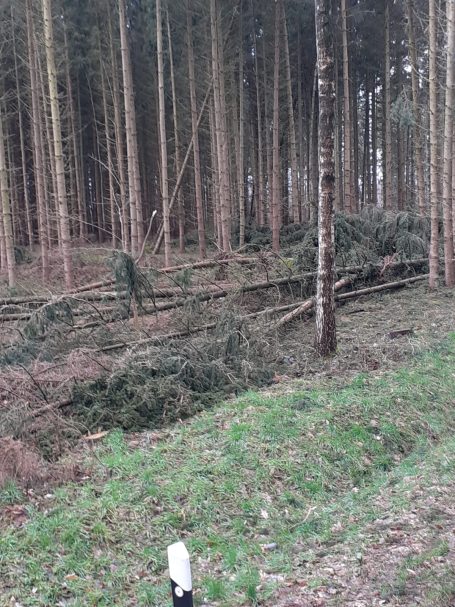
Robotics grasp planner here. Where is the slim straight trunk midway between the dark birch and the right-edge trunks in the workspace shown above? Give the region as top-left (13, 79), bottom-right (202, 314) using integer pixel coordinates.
top-left (383, 0), bottom-right (393, 210)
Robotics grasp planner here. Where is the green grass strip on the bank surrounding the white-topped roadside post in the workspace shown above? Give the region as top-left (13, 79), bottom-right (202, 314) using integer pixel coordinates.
top-left (0, 336), bottom-right (455, 607)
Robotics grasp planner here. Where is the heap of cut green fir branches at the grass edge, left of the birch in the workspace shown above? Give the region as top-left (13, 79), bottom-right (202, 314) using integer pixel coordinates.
top-left (68, 314), bottom-right (273, 431)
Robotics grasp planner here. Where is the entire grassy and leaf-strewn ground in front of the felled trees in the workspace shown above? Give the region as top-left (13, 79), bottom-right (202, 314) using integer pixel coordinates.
top-left (0, 258), bottom-right (455, 607)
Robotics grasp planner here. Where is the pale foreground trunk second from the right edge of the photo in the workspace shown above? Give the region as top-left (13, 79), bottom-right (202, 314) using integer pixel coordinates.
top-left (428, 0), bottom-right (439, 289)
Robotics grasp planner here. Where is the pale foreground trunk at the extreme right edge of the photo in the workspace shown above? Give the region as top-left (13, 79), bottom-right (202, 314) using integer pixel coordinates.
top-left (442, 0), bottom-right (455, 287)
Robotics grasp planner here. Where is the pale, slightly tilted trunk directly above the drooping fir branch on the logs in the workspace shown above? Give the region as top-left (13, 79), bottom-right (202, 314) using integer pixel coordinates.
top-left (119, 0), bottom-right (144, 257)
